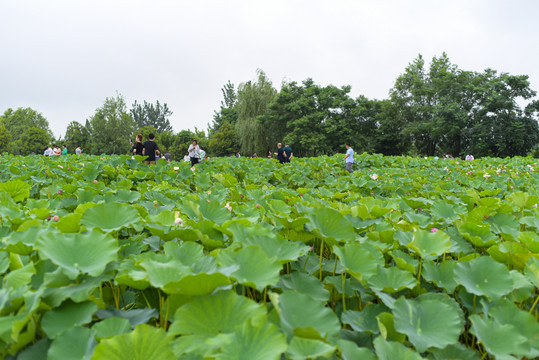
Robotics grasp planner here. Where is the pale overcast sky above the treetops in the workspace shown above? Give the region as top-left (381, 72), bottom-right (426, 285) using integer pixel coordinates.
top-left (0, 0), bottom-right (539, 136)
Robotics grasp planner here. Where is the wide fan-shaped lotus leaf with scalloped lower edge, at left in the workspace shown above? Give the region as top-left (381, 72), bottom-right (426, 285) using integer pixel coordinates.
top-left (36, 230), bottom-right (118, 279)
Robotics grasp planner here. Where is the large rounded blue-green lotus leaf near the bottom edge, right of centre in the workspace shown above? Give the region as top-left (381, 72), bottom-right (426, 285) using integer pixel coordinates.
top-left (393, 293), bottom-right (464, 352)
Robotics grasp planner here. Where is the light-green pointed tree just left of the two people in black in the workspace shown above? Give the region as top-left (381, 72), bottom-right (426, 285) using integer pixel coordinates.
top-left (89, 94), bottom-right (135, 154)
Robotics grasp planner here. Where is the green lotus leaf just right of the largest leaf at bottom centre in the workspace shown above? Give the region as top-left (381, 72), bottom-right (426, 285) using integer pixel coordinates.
top-left (272, 291), bottom-right (341, 339)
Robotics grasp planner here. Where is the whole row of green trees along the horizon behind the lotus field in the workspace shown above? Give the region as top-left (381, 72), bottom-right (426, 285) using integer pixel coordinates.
top-left (0, 53), bottom-right (539, 159)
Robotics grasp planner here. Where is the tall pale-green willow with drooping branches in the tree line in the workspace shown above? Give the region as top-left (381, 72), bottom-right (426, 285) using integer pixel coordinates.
top-left (236, 69), bottom-right (277, 154)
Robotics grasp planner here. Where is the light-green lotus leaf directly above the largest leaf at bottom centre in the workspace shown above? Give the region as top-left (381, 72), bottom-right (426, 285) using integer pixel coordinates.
top-left (217, 245), bottom-right (282, 291)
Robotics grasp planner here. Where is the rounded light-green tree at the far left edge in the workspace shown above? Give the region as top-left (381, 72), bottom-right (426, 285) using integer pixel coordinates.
top-left (0, 108), bottom-right (52, 155)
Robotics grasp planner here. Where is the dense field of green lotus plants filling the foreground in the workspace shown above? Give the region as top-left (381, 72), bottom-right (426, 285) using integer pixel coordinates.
top-left (0, 155), bottom-right (539, 360)
